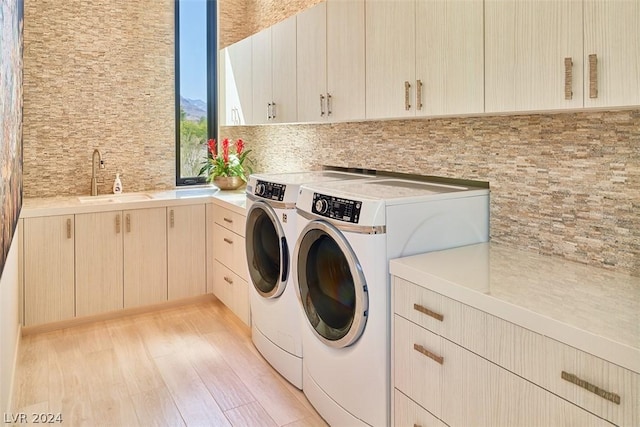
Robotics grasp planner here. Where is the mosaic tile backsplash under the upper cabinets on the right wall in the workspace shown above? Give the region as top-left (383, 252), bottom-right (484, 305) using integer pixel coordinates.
top-left (220, 109), bottom-right (640, 275)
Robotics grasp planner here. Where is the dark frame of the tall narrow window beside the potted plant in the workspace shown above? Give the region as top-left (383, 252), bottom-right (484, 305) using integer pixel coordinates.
top-left (174, 0), bottom-right (218, 186)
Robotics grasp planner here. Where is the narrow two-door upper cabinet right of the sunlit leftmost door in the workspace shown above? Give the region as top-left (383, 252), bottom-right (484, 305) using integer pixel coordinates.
top-left (251, 16), bottom-right (297, 124)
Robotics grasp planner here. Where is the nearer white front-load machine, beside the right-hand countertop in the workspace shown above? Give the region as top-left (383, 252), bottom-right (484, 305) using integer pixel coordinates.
top-left (293, 178), bottom-right (489, 426)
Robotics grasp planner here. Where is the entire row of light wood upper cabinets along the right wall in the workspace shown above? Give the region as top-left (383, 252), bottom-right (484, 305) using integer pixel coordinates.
top-left (220, 0), bottom-right (640, 125)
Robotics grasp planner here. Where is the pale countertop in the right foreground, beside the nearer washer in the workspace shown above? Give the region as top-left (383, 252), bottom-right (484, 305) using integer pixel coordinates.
top-left (390, 243), bottom-right (640, 373)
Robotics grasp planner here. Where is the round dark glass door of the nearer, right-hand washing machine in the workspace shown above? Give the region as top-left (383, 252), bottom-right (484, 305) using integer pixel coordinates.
top-left (293, 221), bottom-right (369, 348)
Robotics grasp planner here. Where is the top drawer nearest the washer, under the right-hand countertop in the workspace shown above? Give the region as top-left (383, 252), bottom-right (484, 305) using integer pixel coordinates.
top-left (393, 277), bottom-right (487, 356)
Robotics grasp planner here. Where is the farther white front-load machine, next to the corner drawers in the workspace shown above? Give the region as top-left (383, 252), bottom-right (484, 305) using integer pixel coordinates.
top-left (245, 171), bottom-right (371, 389)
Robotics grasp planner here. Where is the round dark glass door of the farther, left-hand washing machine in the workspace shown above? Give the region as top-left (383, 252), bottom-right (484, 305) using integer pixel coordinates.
top-left (245, 201), bottom-right (289, 298)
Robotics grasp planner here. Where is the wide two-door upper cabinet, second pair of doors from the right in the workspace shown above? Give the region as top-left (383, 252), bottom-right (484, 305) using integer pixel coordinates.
top-left (366, 0), bottom-right (484, 118)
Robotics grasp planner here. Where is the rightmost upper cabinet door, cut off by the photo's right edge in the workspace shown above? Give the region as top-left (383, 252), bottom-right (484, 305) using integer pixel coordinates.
top-left (584, 0), bottom-right (640, 107)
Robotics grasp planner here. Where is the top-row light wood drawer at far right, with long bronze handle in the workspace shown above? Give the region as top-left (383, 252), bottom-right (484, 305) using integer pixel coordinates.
top-left (487, 315), bottom-right (640, 426)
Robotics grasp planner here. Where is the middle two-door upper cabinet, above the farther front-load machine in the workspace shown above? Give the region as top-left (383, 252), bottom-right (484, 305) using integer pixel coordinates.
top-left (297, 0), bottom-right (365, 122)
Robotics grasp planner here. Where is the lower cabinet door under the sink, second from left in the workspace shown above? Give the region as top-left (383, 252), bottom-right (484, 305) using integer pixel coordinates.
top-left (76, 211), bottom-right (123, 316)
